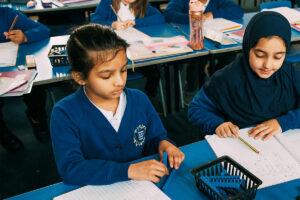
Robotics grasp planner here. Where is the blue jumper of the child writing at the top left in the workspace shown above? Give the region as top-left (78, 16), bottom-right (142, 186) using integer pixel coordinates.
top-left (0, 8), bottom-right (50, 43)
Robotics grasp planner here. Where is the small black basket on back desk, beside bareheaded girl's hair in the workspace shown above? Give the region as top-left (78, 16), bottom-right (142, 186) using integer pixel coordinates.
top-left (48, 45), bottom-right (69, 67)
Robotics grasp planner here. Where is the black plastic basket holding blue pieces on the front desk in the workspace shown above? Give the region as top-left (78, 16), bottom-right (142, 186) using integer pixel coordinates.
top-left (191, 156), bottom-right (262, 200)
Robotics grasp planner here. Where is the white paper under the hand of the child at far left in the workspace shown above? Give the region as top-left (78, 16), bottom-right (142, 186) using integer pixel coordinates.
top-left (0, 42), bottom-right (19, 67)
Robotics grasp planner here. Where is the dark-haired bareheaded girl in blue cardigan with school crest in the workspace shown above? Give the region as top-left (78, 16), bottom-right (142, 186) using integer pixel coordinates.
top-left (50, 24), bottom-right (184, 185)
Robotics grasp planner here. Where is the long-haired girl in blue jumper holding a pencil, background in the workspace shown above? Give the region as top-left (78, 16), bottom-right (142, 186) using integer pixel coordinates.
top-left (91, 0), bottom-right (165, 30)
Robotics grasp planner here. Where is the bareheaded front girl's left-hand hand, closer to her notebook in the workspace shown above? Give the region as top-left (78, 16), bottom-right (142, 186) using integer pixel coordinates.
top-left (128, 159), bottom-right (169, 183)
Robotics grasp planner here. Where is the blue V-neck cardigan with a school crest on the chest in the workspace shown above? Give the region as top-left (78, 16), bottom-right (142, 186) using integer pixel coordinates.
top-left (50, 88), bottom-right (169, 185)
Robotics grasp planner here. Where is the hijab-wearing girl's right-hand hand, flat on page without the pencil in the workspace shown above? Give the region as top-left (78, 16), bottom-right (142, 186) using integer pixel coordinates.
top-left (248, 119), bottom-right (282, 141)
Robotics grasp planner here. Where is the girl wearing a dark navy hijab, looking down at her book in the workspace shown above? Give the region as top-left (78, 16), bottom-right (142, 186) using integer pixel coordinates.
top-left (188, 11), bottom-right (300, 140)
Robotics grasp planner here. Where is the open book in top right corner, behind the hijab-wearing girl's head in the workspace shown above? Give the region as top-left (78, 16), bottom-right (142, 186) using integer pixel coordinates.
top-left (262, 7), bottom-right (300, 31)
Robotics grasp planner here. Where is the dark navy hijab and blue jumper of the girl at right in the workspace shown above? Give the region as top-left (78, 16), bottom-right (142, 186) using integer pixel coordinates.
top-left (188, 11), bottom-right (300, 134)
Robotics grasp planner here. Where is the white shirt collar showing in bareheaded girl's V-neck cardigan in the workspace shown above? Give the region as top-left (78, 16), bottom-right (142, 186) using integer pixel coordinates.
top-left (83, 88), bottom-right (127, 132)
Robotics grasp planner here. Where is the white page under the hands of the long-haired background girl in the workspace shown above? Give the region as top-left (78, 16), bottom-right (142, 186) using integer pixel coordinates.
top-left (115, 27), bottom-right (151, 43)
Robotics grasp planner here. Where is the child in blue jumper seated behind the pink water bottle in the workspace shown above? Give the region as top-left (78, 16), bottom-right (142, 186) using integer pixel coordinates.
top-left (164, 0), bottom-right (243, 105)
